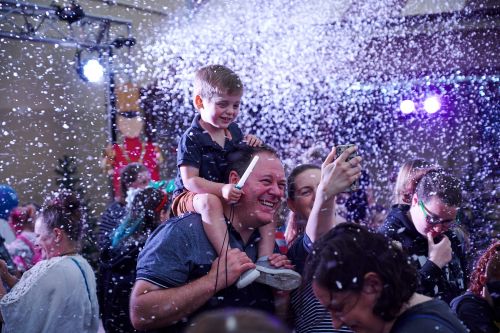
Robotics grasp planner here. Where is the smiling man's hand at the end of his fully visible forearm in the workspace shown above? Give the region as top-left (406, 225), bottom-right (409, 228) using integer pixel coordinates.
top-left (208, 249), bottom-right (255, 292)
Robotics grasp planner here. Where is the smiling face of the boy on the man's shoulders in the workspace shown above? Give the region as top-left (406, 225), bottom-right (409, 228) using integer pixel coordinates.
top-left (195, 93), bottom-right (242, 129)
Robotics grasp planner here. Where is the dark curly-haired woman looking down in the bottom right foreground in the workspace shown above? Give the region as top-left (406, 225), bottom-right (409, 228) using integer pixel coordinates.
top-left (306, 223), bottom-right (467, 333)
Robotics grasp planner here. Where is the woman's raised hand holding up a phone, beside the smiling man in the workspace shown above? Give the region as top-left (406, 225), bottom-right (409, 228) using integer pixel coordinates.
top-left (320, 147), bottom-right (362, 198)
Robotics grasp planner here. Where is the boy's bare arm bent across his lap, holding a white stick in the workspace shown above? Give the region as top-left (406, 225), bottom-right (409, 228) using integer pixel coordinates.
top-left (179, 165), bottom-right (242, 202)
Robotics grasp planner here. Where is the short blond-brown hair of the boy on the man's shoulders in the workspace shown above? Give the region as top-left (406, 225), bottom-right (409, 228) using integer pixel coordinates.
top-left (193, 65), bottom-right (243, 106)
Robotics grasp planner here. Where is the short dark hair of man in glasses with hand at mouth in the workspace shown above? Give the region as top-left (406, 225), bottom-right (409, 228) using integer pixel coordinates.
top-left (416, 170), bottom-right (462, 207)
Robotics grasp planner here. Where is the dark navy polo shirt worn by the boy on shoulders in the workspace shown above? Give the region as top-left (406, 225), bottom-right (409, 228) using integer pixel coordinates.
top-left (174, 114), bottom-right (243, 196)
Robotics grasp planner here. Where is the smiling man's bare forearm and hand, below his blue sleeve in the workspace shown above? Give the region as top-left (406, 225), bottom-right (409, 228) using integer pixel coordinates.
top-left (130, 249), bottom-right (255, 330)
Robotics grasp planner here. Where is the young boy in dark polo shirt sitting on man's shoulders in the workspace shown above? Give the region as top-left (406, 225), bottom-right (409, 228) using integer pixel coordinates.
top-left (172, 65), bottom-right (296, 288)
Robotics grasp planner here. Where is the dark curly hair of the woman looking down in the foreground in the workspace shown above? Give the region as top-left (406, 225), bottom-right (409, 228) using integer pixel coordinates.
top-left (305, 223), bottom-right (417, 321)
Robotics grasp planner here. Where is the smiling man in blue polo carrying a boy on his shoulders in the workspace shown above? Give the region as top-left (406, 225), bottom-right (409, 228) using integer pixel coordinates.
top-left (130, 145), bottom-right (291, 332)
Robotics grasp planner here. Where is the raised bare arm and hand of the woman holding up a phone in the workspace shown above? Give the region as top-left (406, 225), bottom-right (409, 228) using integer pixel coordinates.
top-left (306, 147), bottom-right (361, 243)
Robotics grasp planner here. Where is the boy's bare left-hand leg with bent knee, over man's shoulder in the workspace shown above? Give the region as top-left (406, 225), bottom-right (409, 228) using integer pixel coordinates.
top-left (193, 193), bottom-right (231, 255)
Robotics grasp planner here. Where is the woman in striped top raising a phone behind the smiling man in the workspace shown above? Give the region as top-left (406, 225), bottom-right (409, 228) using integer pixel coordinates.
top-left (287, 147), bottom-right (361, 333)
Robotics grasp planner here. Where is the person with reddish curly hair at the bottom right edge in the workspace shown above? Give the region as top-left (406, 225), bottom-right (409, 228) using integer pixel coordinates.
top-left (451, 240), bottom-right (500, 333)
